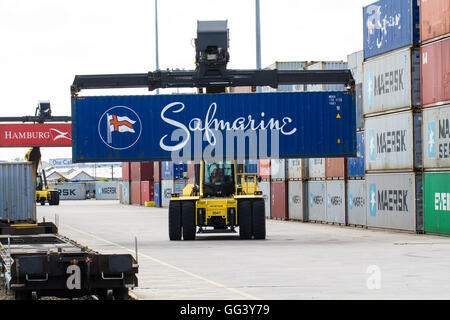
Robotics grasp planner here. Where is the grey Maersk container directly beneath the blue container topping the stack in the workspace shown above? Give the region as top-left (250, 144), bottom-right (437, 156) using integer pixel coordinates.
top-left (363, 48), bottom-right (421, 115)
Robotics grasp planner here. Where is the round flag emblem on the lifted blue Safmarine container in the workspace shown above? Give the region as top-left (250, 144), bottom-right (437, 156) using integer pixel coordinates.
top-left (98, 106), bottom-right (142, 150)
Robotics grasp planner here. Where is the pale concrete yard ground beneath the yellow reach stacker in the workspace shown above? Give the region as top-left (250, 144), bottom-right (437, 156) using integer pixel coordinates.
top-left (38, 200), bottom-right (450, 300)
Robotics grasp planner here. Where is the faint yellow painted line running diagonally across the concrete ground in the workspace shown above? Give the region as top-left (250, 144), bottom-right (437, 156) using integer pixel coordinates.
top-left (63, 224), bottom-right (260, 300)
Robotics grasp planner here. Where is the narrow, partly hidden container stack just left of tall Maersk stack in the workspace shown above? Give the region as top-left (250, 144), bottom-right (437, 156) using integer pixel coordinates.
top-left (346, 50), bottom-right (367, 227)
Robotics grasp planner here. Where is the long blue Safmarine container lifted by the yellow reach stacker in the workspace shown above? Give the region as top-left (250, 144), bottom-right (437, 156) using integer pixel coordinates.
top-left (72, 92), bottom-right (356, 162)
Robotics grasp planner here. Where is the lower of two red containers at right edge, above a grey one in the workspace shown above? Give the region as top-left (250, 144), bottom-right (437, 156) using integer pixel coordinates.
top-left (420, 37), bottom-right (450, 107)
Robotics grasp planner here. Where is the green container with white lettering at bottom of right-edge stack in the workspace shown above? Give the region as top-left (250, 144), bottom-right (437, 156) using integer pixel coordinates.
top-left (424, 172), bottom-right (450, 235)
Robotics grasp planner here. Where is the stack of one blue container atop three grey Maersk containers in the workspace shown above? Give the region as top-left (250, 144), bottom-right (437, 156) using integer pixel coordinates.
top-left (363, 0), bottom-right (423, 232)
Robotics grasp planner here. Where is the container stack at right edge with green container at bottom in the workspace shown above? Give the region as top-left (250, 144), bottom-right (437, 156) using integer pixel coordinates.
top-left (420, 0), bottom-right (450, 235)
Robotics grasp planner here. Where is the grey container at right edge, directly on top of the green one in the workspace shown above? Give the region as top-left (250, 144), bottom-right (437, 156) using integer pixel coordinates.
top-left (422, 105), bottom-right (450, 170)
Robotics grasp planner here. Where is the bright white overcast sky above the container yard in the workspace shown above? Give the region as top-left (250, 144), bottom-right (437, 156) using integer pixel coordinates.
top-left (0, 0), bottom-right (374, 160)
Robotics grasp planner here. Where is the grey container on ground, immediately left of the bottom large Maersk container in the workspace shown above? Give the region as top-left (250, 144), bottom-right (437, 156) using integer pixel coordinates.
top-left (346, 180), bottom-right (367, 226)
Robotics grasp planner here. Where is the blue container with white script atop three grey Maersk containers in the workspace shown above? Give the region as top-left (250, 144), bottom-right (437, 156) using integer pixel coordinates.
top-left (363, 0), bottom-right (420, 59)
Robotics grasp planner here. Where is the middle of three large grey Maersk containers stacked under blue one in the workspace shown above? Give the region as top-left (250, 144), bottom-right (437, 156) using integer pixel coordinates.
top-left (365, 111), bottom-right (422, 172)
